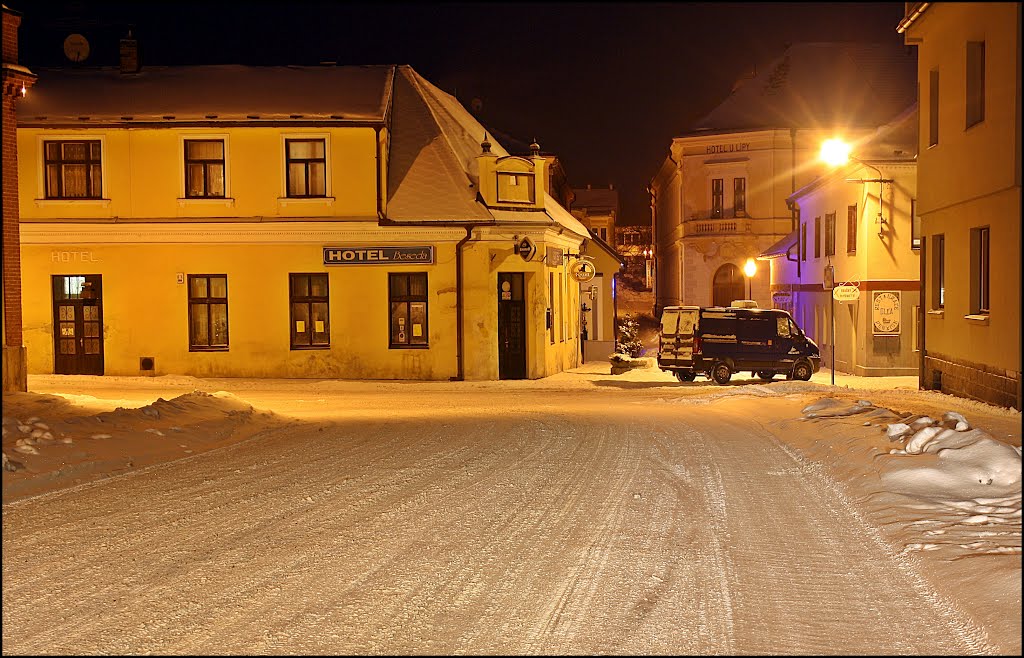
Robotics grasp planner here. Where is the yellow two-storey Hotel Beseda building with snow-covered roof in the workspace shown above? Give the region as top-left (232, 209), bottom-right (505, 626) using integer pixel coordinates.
top-left (17, 63), bottom-right (589, 380)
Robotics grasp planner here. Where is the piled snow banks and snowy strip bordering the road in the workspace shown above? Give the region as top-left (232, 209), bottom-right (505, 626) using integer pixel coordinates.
top-left (3, 368), bottom-right (1021, 652)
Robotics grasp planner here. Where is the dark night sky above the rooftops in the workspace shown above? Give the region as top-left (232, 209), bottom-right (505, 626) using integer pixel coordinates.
top-left (12, 0), bottom-right (903, 224)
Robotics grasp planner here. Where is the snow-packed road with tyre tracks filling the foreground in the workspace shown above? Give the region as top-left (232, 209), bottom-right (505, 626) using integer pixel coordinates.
top-left (3, 390), bottom-right (989, 655)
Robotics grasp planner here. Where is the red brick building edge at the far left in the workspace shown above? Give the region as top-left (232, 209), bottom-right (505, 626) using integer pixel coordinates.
top-left (0, 5), bottom-right (36, 393)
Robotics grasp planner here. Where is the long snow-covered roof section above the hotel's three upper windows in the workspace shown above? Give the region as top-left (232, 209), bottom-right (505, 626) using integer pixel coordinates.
top-left (16, 64), bottom-right (394, 126)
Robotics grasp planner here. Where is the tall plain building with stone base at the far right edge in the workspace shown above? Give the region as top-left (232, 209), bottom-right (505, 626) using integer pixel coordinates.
top-left (897, 2), bottom-right (1022, 409)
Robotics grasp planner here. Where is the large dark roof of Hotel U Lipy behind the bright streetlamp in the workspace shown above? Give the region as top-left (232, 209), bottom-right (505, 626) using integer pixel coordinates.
top-left (693, 42), bottom-right (918, 132)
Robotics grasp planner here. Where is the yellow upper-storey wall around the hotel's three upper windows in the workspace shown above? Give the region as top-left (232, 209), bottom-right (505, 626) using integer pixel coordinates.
top-left (17, 127), bottom-right (377, 220)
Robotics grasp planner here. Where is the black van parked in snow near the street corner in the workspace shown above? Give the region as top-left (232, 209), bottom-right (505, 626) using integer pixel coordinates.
top-left (657, 306), bottom-right (821, 384)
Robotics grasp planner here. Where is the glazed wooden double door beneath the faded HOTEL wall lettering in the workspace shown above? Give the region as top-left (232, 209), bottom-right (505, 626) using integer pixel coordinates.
top-left (52, 274), bottom-right (103, 375)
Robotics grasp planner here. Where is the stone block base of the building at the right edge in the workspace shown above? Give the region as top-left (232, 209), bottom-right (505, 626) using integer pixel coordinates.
top-left (921, 352), bottom-right (1021, 410)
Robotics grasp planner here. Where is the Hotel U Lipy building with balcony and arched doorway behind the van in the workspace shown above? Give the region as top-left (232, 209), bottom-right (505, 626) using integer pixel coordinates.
top-left (649, 43), bottom-right (916, 312)
